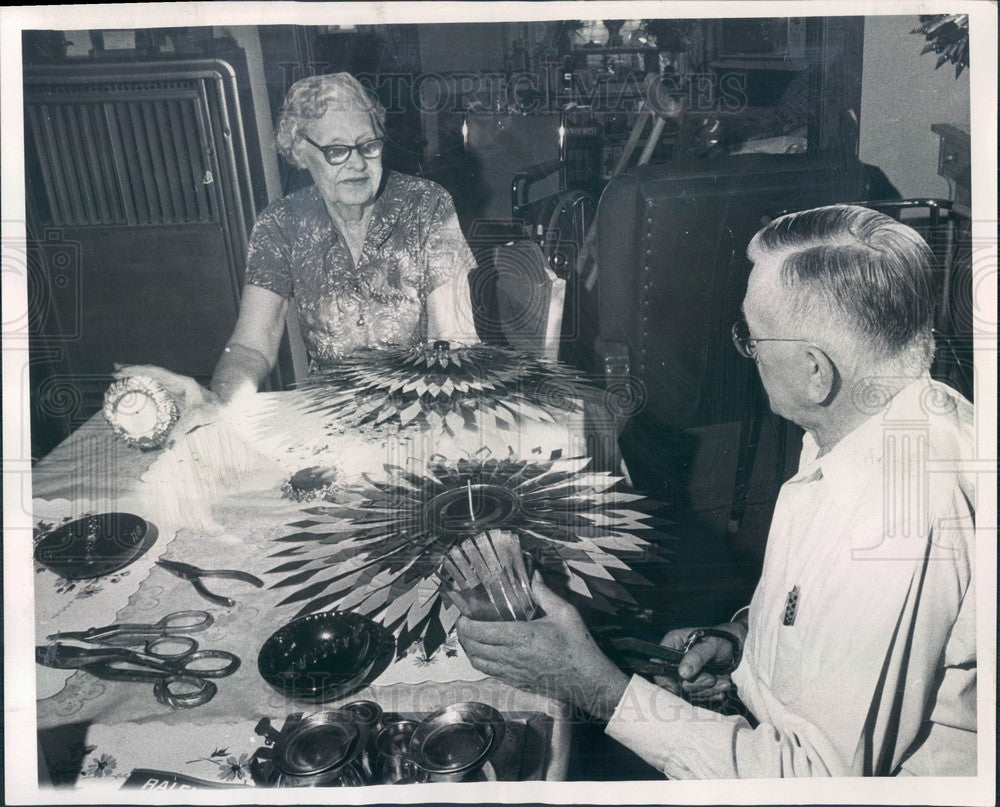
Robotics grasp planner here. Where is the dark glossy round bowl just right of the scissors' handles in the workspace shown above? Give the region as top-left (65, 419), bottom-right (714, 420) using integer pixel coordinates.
top-left (257, 611), bottom-right (396, 703)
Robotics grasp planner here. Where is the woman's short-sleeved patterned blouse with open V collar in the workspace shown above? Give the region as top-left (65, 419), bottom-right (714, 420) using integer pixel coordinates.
top-left (246, 171), bottom-right (475, 369)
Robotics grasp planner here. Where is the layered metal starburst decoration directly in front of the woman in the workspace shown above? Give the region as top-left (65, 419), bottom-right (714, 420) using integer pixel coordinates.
top-left (262, 342), bottom-right (585, 442)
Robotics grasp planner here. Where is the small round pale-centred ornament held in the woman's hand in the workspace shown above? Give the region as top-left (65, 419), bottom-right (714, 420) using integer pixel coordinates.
top-left (104, 375), bottom-right (180, 451)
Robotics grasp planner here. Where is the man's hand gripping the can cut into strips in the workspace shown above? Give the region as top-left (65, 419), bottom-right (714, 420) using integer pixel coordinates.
top-left (456, 573), bottom-right (628, 720)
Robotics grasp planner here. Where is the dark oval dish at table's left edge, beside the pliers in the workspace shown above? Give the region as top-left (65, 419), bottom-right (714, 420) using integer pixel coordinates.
top-left (35, 513), bottom-right (157, 580)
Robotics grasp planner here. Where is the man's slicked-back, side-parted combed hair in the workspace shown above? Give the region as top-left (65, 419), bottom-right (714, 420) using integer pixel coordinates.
top-left (747, 205), bottom-right (939, 361)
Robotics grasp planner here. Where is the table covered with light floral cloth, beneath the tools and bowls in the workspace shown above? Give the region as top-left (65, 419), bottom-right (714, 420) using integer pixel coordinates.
top-left (33, 392), bottom-right (582, 788)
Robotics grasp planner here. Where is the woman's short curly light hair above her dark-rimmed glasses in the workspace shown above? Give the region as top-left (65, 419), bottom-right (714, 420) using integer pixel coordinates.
top-left (274, 73), bottom-right (385, 165)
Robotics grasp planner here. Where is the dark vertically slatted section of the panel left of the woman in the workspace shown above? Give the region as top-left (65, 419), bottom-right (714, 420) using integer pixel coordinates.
top-left (26, 81), bottom-right (219, 226)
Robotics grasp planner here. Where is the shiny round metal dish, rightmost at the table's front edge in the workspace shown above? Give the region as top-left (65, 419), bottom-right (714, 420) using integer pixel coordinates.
top-left (407, 702), bottom-right (505, 774)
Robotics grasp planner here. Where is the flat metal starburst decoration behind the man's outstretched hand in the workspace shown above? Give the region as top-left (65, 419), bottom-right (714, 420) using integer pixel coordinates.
top-left (269, 453), bottom-right (652, 655)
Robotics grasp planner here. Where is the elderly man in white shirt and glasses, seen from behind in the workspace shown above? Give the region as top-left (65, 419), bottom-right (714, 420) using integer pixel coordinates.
top-left (458, 206), bottom-right (976, 778)
